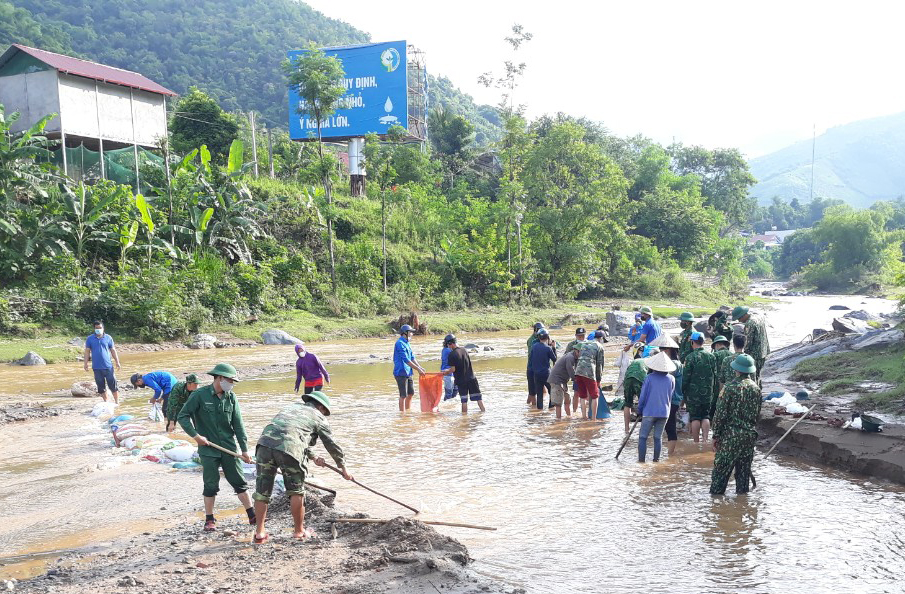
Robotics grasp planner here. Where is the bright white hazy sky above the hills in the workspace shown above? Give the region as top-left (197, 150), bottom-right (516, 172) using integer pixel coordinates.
top-left (304, 0), bottom-right (905, 157)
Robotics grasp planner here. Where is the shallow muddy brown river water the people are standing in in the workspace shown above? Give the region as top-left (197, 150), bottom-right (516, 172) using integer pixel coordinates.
top-left (0, 297), bottom-right (905, 593)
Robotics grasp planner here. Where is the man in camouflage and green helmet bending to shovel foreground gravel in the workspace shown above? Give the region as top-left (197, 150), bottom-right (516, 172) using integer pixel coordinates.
top-left (252, 390), bottom-right (352, 544)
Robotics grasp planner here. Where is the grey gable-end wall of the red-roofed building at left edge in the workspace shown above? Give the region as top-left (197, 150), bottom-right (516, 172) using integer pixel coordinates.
top-left (0, 70), bottom-right (60, 132)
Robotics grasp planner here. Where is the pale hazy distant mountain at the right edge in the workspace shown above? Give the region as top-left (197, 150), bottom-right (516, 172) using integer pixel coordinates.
top-left (749, 113), bottom-right (905, 208)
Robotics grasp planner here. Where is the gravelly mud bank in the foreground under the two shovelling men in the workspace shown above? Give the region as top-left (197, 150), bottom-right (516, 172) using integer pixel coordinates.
top-left (7, 492), bottom-right (508, 594)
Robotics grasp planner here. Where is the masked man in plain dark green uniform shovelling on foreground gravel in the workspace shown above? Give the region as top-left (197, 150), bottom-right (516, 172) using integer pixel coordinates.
top-left (176, 363), bottom-right (255, 532)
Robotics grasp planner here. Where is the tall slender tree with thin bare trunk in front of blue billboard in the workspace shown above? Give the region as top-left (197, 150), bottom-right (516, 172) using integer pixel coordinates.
top-left (283, 42), bottom-right (346, 295)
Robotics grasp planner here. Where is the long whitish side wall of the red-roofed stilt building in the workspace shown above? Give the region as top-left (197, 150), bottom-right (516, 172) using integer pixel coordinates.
top-left (60, 73), bottom-right (166, 146)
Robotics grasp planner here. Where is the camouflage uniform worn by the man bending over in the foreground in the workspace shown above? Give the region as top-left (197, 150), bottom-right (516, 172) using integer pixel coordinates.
top-left (254, 400), bottom-right (345, 503)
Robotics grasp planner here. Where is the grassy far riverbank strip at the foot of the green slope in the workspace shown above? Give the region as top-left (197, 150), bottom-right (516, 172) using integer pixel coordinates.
top-left (0, 296), bottom-right (775, 363)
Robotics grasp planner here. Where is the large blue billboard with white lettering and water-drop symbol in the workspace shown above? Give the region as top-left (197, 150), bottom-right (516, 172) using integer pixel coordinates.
top-left (288, 41), bottom-right (408, 140)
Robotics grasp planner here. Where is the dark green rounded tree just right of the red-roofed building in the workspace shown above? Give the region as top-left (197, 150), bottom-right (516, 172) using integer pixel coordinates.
top-left (170, 87), bottom-right (239, 160)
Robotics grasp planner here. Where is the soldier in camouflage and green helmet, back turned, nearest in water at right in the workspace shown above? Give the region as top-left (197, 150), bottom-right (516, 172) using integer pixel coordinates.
top-left (710, 355), bottom-right (761, 495)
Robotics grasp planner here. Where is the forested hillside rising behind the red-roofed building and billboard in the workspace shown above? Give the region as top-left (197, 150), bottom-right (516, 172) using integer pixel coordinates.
top-left (0, 0), bottom-right (495, 140)
